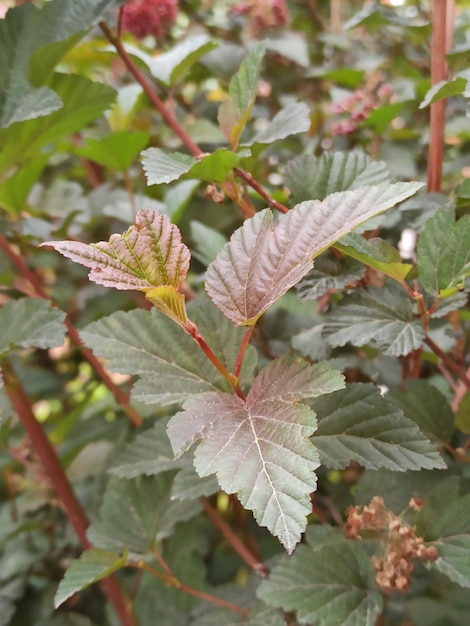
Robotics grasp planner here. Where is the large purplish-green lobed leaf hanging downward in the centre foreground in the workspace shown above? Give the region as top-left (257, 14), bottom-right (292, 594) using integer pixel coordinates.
top-left (168, 358), bottom-right (344, 552)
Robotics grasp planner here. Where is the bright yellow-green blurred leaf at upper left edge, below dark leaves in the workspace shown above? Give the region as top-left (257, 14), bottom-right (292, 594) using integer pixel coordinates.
top-left (0, 74), bottom-right (116, 173)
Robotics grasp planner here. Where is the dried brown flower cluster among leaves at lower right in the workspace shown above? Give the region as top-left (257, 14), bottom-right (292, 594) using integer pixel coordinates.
top-left (345, 496), bottom-right (439, 592)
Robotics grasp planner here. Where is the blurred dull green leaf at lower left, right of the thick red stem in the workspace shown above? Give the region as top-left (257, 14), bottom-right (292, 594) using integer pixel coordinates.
top-left (88, 472), bottom-right (201, 559)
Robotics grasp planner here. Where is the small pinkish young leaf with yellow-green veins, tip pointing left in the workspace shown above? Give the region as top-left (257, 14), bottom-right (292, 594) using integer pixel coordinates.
top-left (41, 209), bottom-right (190, 291)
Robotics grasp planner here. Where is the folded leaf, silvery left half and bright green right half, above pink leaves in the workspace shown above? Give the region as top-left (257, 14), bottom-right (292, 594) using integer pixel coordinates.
top-left (142, 148), bottom-right (246, 185)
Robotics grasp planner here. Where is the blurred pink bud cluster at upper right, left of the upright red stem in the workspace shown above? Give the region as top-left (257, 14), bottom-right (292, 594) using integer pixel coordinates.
top-left (329, 84), bottom-right (392, 135)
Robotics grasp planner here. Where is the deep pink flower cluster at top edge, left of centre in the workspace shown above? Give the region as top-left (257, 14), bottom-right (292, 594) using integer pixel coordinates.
top-left (122, 0), bottom-right (178, 39)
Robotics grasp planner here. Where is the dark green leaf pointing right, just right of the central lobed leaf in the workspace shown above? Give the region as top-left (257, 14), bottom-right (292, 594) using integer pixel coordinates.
top-left (311, 383), bottom-right (446, 472)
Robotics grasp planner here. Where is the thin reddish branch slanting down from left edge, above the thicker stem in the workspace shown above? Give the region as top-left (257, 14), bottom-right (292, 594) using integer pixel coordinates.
top-left (0, 234), bottom-right (142, 426)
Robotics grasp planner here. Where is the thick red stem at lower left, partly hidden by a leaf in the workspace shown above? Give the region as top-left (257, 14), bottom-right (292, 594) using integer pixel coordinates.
top-left (2, 358), bottom-right (137, 626)
